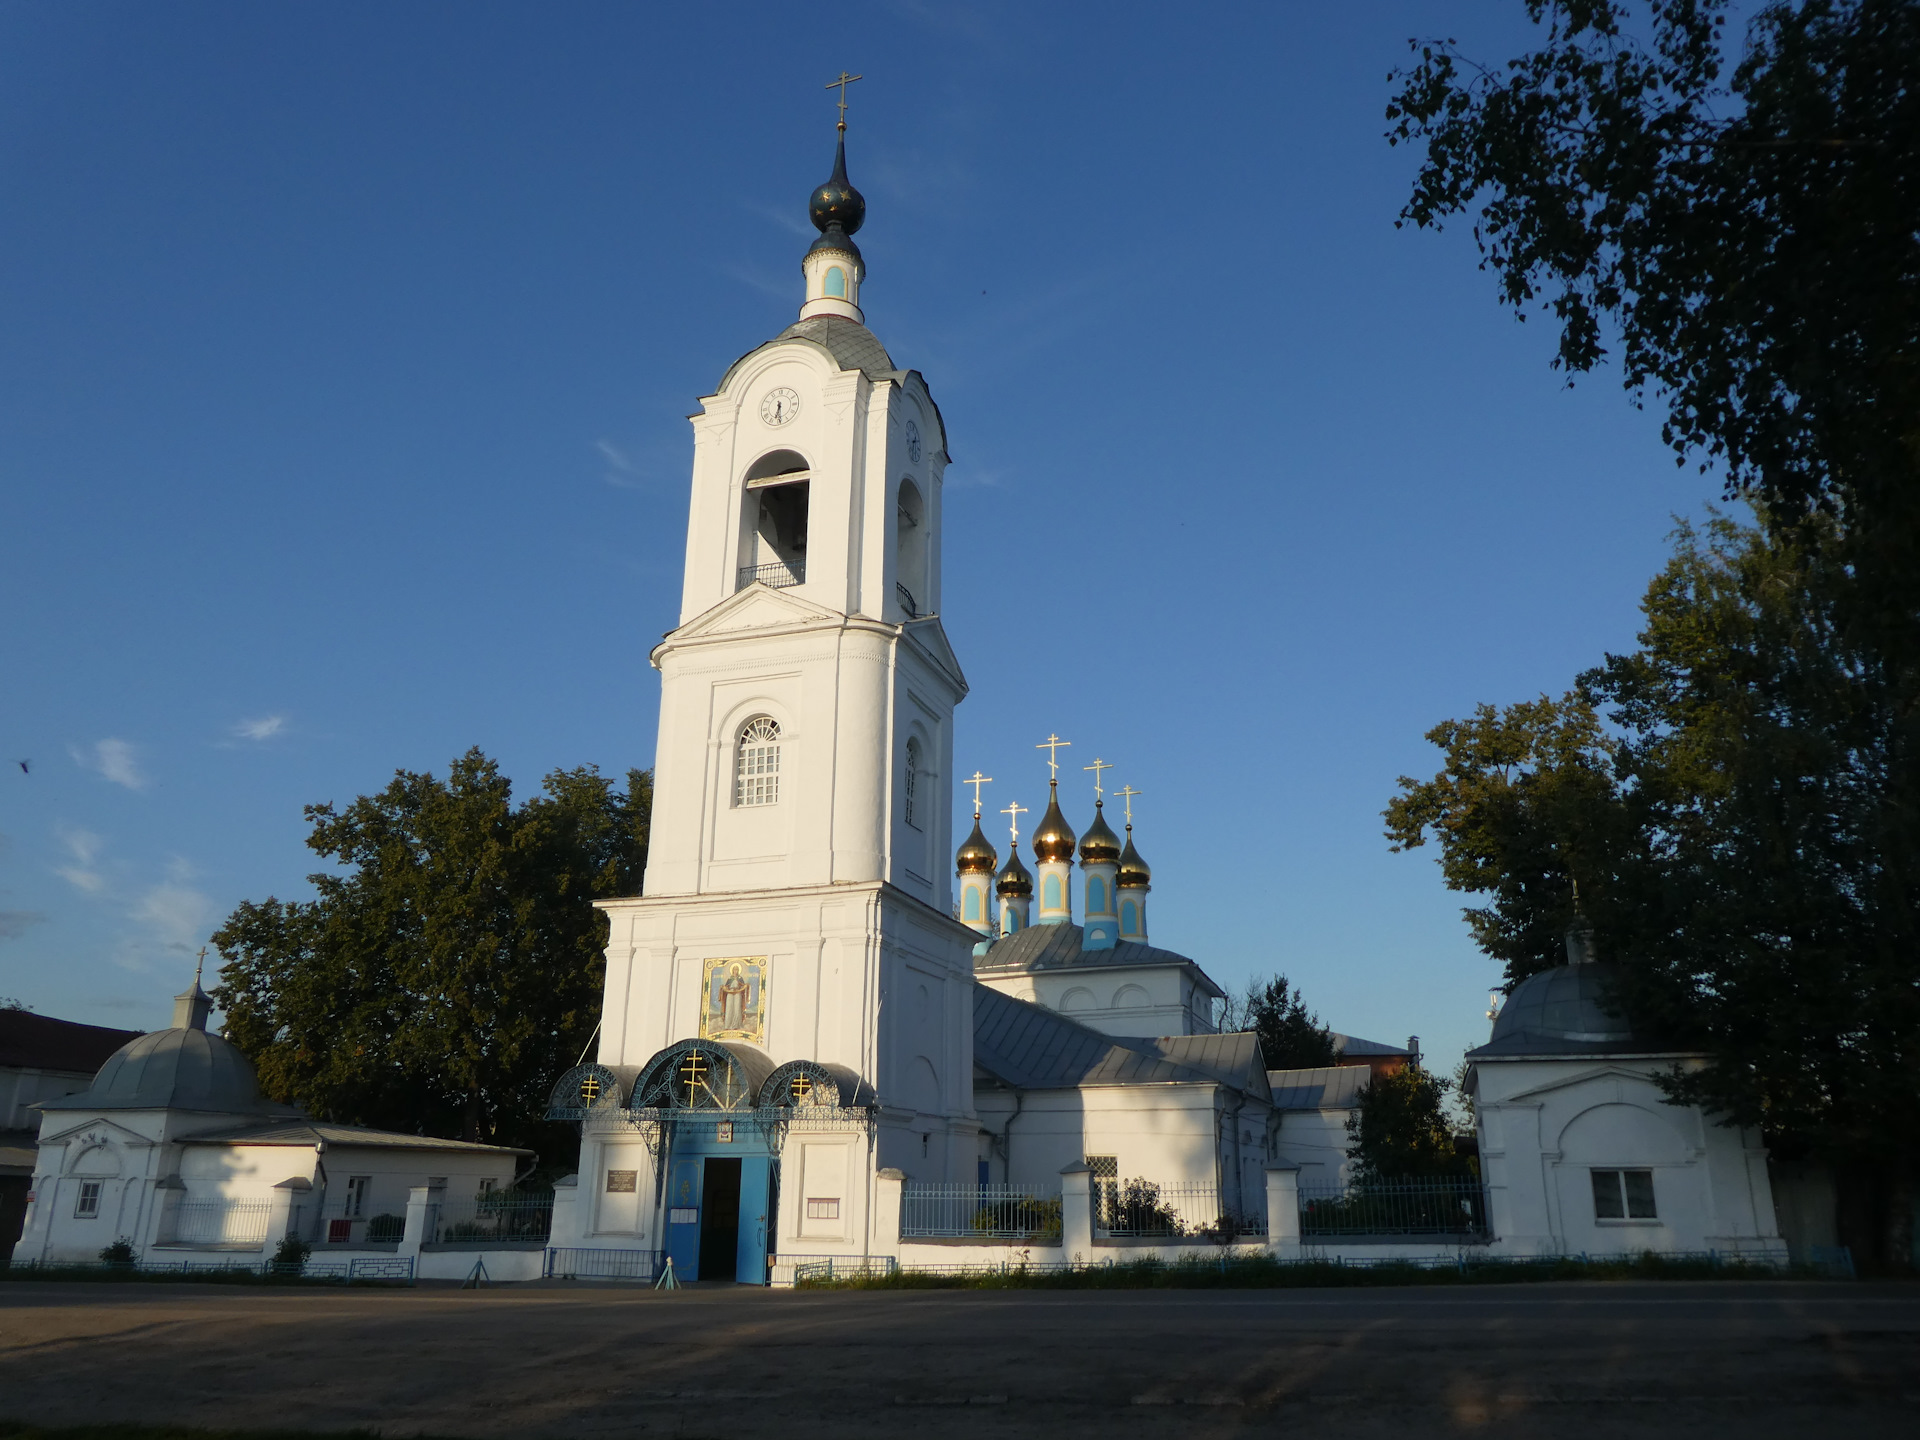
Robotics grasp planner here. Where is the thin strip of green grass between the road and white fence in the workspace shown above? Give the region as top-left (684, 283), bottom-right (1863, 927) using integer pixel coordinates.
top-left (795, 1254), bottom-right (1830, 1290)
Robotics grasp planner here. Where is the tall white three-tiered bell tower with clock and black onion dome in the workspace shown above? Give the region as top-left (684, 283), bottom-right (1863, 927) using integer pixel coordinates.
top-left (580, 107), bottom-right (991, 1251)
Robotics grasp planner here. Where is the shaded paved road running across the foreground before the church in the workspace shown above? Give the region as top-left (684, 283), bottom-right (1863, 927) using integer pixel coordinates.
top-left (0, 1283), bottom-right (1920, 1440)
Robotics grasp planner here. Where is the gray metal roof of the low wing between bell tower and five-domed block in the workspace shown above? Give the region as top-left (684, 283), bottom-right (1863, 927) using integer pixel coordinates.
top-left (973, 983), bottom-right (1267, 1098)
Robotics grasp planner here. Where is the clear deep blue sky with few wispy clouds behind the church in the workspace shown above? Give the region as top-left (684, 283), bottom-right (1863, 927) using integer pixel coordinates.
top-left (0, 0), bottom-right (1713, 1066)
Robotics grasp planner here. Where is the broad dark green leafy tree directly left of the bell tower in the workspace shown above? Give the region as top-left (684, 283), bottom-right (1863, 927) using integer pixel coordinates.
top-left (213, 751), bottom-right (653, 1154)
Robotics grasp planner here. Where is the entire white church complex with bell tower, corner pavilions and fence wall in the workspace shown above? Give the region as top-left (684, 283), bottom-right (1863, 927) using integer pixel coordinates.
top-left (15, 112), bottom-right (1818, 1283)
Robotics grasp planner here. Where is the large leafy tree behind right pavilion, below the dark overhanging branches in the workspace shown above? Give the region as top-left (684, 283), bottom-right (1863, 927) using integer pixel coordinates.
top-left (1386, 518), bottom-right (1920, 1260)
